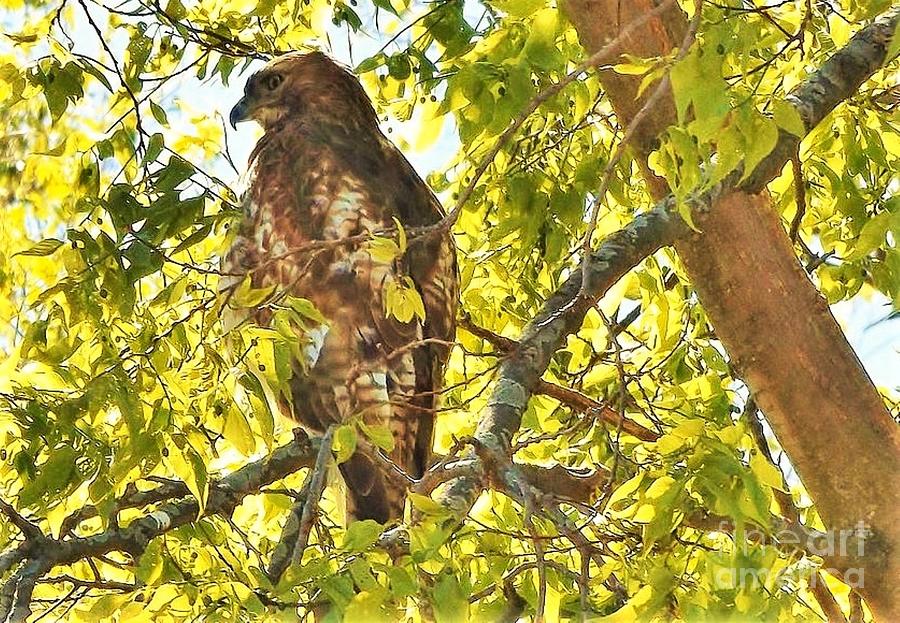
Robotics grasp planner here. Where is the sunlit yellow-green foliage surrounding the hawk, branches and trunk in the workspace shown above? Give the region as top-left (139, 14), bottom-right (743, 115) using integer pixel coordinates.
top-left (0, 0), bottom-right (900, 621)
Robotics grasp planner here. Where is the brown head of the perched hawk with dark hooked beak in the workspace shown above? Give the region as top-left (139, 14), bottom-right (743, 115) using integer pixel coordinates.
top-left (228, 52), bottom-right (378, 129)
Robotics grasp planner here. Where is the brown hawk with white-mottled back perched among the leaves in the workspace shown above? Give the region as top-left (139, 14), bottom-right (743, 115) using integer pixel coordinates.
top-left (223, 52), bottom-right (458, 523)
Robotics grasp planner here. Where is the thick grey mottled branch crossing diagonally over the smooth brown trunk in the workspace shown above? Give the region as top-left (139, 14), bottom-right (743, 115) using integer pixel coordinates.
top-left (432, 2), bottom-right (900, 572)
